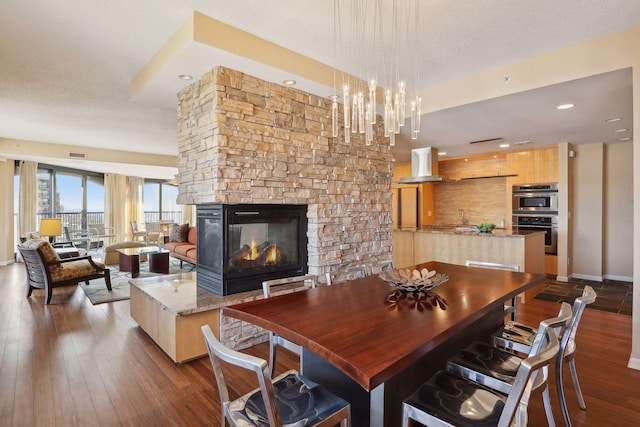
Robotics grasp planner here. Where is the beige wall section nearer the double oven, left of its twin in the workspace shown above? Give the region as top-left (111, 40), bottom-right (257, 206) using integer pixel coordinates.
top-left (569, 143), bottom-right (604, 280)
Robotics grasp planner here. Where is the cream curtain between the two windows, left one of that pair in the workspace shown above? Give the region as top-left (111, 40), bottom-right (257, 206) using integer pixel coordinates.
top-left (104, 173), bottom-right (129, 242)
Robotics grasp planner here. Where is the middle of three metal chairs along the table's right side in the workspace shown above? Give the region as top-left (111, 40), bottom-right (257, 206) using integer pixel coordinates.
top-left (446, 302), bottom-right (572, 427)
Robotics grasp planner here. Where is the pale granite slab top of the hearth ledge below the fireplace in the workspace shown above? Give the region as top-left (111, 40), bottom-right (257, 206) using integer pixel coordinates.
top-left (129, 272), bottom-right (262, 316)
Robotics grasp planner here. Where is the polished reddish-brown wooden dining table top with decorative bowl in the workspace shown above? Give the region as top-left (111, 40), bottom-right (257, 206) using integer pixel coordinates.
top-left (222, 262), bottom-right (545, 391)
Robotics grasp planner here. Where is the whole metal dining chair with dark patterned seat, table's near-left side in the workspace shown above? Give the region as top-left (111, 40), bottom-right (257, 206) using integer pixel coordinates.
top-left (202, 325), bottom-right (351, 427)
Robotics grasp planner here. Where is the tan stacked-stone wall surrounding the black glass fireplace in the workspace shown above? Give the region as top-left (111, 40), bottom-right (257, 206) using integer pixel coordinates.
top-left (178, 67), bottom-right (392, 348)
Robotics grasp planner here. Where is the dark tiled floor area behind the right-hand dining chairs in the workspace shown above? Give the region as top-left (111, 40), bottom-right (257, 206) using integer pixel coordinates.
top-left (534, 279), bottom-right (633, 316)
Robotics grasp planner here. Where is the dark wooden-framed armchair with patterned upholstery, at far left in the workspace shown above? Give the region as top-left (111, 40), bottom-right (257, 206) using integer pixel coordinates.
top-left (18, 240), bottom-right (111, 304)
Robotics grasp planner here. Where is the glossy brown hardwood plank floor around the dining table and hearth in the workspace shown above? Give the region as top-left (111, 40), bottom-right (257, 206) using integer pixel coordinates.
top-left (0, 264), bottom-right (640, 427)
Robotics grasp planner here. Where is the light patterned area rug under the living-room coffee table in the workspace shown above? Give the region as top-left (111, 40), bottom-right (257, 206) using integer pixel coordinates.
top-left (80, 260), bottom-right (195, 305)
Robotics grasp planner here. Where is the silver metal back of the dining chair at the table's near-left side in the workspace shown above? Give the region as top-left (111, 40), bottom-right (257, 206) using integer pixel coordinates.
top-left (201, 325), bottom-right (282, 426)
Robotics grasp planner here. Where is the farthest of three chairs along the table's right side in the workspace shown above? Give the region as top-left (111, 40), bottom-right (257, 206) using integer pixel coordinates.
top-left (493, 285), bottom-right (597, 426)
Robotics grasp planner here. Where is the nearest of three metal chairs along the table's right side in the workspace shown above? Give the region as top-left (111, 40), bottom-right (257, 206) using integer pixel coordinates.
top-left (402, 314), bottom-right (560, 427)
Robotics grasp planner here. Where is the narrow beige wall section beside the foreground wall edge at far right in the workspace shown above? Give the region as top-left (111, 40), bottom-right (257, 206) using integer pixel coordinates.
top-left (603, 142), bottom-right (633, 281)
